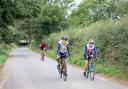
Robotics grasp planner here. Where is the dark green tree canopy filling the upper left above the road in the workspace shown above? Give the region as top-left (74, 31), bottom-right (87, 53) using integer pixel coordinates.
top-left (0, 0), bottom-right (72, 43)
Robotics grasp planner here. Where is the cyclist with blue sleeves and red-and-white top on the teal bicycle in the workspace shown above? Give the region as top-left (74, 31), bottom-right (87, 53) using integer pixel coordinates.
top-left (83, 39), bottom-right (97, 76)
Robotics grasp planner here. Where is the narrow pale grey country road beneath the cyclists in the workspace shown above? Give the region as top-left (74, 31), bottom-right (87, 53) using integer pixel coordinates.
top-left (3, 47), bottom-right (128, 89)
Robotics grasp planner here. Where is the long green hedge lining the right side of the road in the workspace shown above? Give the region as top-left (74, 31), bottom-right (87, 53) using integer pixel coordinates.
top-left (49, 17), bottom-right (128, 76)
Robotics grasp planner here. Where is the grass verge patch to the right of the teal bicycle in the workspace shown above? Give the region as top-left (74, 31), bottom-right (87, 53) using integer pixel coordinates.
top-left (95, 63), bottom-right (128, 81)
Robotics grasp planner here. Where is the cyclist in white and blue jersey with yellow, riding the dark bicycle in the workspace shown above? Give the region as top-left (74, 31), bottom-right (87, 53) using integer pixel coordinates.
top-left (57, 36), bottom-right (68, 75)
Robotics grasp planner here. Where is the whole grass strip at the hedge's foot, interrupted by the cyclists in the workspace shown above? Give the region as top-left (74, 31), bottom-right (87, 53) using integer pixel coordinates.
top-left (47, 49), bottom-right (128, 81)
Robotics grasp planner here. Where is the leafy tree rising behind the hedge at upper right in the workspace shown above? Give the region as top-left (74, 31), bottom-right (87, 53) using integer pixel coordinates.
top-left (69, 0), bottom-right (128, 25)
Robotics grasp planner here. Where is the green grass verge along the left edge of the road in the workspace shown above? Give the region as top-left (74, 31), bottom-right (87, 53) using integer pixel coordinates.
top-left (0, 47), bottom-right (11, 64)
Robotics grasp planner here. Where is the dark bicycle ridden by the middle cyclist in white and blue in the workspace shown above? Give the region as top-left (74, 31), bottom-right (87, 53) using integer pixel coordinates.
top-left (58, 56), bottom-right (67, 81)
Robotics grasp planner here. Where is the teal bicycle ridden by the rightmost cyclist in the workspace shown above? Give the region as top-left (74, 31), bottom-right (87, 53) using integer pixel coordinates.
top-left (85, 55), bottom-right (95, 81)
